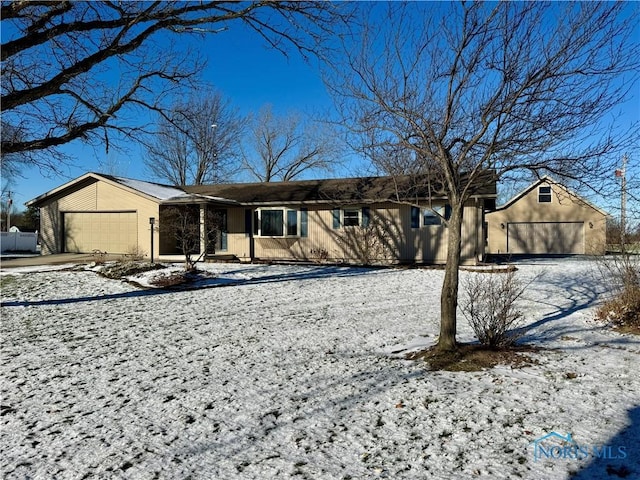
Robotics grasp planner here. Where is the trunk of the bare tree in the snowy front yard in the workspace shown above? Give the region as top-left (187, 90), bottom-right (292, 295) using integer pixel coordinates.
top-left (438, 202), bottom-right (464, 351)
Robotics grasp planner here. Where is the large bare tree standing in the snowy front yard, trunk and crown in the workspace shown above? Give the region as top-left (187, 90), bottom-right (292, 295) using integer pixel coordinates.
top-left (327, 2), bottom-right (640, 350)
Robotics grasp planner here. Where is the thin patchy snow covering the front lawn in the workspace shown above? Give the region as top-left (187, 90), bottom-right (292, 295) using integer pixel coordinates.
top-left (0, 259), bottom-right (640, 480)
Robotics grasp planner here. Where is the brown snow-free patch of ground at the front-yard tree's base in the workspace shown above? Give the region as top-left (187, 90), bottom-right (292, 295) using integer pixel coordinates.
top-left (407, 344), bottom-right (539, 372)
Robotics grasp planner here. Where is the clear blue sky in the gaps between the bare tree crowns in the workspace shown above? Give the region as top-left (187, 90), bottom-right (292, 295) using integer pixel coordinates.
top-left (6, 3), bottom-right (640, 218)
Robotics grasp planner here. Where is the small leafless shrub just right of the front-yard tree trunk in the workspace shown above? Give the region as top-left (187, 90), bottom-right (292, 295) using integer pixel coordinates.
top-left (461, 271), bottom-right (525, 348)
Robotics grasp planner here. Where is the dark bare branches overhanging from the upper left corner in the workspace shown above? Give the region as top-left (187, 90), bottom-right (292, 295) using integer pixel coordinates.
top-left (0, 0), bottom-right (350, 176)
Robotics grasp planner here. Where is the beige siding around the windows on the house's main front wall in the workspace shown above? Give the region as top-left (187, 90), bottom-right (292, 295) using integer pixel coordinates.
top-left (227, 202), bottom-right (484, 264)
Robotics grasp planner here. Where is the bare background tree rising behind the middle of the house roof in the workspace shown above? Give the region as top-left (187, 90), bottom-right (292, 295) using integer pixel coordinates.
top-left (243, 105), bottom-right (339, 182)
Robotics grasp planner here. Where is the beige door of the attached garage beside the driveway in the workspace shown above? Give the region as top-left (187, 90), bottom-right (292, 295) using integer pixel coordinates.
top-left (64, 212), bottom-right (138, 253)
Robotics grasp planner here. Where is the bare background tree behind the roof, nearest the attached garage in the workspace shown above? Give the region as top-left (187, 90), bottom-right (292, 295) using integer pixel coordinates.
top-left (145, 92), bottom-right (245, 185)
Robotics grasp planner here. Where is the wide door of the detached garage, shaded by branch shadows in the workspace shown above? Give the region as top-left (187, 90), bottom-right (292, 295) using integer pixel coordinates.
top-left (507, 222), bottom-right (584, 254)
